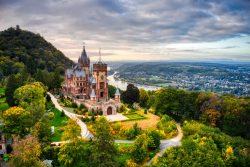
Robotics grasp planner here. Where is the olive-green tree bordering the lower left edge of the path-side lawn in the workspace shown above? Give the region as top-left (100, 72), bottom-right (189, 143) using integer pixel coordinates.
top-left (31, 116), bottom-right (52, 147)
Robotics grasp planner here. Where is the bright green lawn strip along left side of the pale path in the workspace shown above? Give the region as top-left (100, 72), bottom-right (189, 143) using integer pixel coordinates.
top-left (51, 108), bottom-right (70, 142)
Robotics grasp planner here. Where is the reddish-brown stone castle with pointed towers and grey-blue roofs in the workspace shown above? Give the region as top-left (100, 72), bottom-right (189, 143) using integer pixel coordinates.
top-left (62, 46), bottom-right (120, 115)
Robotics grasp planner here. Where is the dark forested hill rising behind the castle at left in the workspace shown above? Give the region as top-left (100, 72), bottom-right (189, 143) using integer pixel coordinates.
top-left (0, 28), bottom-right (74, 76)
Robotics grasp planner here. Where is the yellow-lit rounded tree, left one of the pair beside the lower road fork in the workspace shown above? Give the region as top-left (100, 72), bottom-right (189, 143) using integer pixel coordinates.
top-left (130, 133), bottom-right (148, 163)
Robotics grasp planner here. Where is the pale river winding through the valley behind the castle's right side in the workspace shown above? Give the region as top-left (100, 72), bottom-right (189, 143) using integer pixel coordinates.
top-left (108, 72), bottom-right (159, 91)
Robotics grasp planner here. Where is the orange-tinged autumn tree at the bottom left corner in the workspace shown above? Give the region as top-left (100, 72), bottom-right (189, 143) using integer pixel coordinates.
top-left (10, 135), bottom-right (43, 167)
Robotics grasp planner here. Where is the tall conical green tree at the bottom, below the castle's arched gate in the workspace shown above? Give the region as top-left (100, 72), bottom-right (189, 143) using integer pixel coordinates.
top-left (89, 116), bottom-right (117, 167)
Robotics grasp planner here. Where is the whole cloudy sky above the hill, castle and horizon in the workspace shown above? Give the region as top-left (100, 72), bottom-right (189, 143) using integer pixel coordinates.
top-left (0, 0), bottom-right (250, 62)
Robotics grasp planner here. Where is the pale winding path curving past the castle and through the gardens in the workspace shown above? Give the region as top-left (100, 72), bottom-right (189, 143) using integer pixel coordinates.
top-left (48, 93), bottom-right (183, 164)
